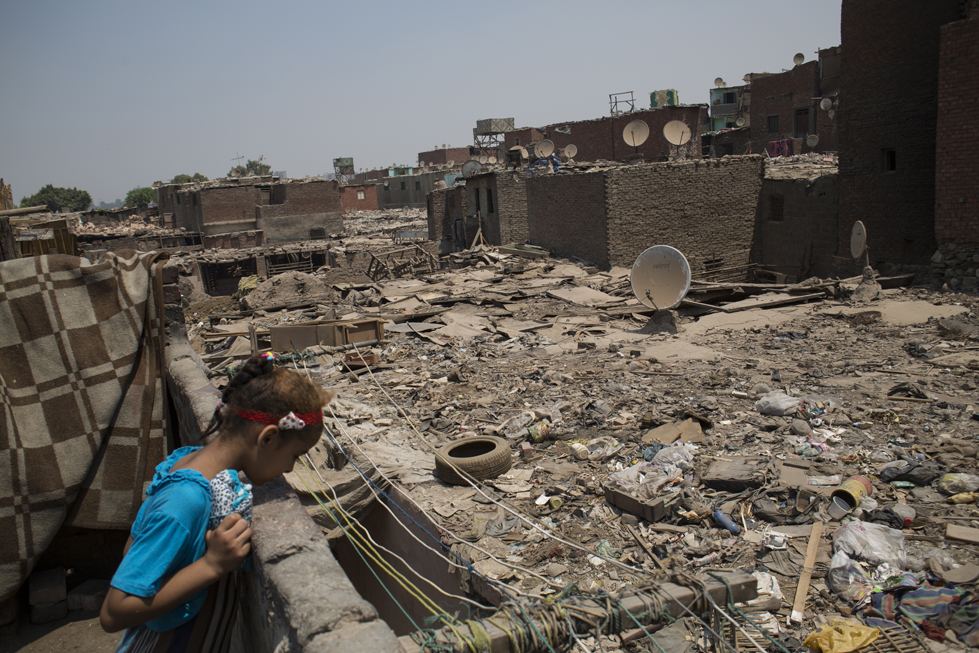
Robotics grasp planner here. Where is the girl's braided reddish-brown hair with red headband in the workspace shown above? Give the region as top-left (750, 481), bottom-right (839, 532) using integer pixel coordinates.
top-left (203, 354), bottom-right (335, 438)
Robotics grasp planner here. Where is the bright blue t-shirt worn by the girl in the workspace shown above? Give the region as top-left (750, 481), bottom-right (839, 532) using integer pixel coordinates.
top-left (111, 447), bottom-right (211, 632)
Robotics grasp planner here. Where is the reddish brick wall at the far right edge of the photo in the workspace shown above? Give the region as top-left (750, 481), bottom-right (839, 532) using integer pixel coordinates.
top-left (935, 11), bottom-right (979, 244)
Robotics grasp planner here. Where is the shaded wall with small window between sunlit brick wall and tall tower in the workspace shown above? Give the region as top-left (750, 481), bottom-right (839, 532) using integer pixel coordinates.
top-left (757, 174), bottom-right (840, 281)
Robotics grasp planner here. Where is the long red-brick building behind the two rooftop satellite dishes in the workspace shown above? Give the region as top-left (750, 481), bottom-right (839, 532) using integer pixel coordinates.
top-left (504, 105), bottom-right (707, 161)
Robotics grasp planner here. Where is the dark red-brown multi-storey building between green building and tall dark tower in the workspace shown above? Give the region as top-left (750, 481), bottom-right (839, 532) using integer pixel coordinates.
top-left (750, 55), bottom-right (839, 156)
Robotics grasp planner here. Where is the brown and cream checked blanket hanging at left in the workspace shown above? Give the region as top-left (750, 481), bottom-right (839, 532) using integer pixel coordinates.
top-left (0, 252), bottom-right (172, 601)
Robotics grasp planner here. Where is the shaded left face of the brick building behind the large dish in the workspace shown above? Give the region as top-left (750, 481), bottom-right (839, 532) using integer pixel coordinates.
top-left (526, 172), bottom-right (608, 268)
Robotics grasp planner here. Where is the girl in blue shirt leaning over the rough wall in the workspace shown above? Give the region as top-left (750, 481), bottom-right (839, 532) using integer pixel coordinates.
top-left (100, 354), bottom-right (333, 653)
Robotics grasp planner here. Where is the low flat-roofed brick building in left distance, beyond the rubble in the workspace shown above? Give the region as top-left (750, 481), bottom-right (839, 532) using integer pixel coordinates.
top-left (165, 177), bottom-right (343, 242)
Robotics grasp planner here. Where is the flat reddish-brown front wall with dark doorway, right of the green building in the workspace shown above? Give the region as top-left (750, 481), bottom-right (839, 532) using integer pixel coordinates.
top-left (750, 61), bottom-right (836, 154)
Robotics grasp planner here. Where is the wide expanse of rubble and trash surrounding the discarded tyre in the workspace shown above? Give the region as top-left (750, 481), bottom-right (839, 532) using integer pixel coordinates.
top-left (189, 241), bottom-right (979, 651)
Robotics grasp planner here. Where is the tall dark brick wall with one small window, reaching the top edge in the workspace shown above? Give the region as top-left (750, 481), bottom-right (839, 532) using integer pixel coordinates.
top-left (838, 0), bottom-right (960, 263)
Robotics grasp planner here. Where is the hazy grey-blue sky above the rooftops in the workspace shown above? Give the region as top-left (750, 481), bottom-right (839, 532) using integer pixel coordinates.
top-left (0, 0), bottom-right (840, 203)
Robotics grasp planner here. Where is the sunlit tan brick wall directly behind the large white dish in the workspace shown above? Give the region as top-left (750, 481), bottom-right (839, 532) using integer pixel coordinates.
top-left (605, 154), bottom-right (765, 274)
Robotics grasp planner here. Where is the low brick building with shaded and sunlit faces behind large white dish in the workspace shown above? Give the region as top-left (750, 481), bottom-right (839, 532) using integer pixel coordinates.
top-left (526, 155), bottom-right (765, 275)
